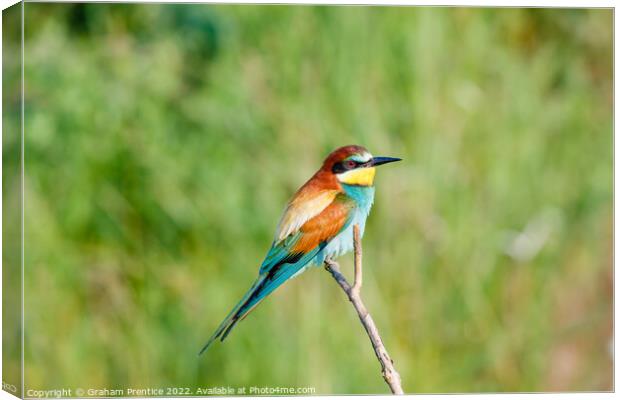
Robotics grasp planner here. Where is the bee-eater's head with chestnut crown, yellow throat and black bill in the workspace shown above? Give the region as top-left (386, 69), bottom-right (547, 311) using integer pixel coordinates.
top-left (322, 145), bottom-right (401, 186)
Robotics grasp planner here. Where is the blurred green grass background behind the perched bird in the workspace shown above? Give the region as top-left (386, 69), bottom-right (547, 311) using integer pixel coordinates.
top-left (4, 3), bottom-right (613, 394)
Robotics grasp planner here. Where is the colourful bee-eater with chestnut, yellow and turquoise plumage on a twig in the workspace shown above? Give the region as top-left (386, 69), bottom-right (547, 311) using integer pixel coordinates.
top-left (199, 145), bottom-right (401, 355)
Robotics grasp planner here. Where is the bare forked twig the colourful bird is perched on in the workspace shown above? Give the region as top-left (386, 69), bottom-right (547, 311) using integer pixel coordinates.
top-left (325, 225), bottom-right (404, 394)
